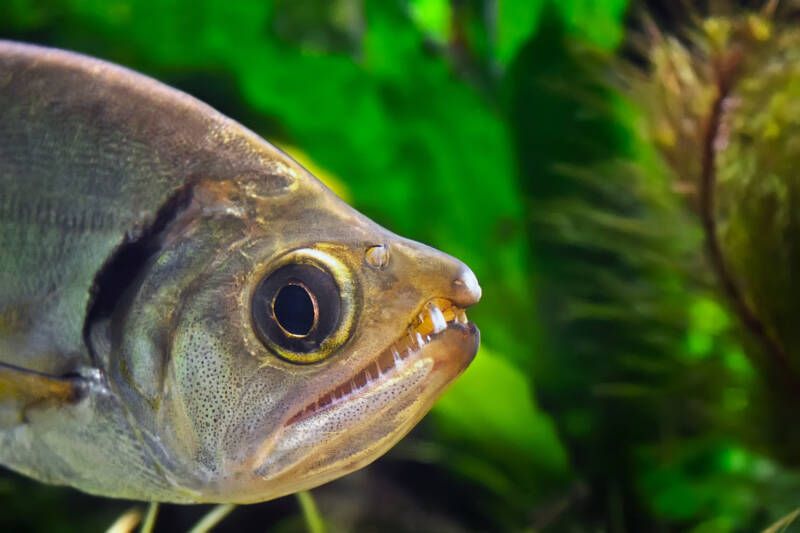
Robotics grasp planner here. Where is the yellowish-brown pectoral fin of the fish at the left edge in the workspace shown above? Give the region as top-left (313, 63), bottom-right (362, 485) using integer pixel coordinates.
top-left (0, 363), bottom-right (80, 428)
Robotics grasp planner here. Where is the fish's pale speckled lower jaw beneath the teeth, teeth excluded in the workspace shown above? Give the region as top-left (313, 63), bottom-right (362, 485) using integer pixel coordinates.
top-left (241, 324), bottom-right (480, 501)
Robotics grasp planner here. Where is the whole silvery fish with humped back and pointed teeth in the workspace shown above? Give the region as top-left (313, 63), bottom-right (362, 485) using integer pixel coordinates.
top-left (0, 41), bottom-right (481, 504)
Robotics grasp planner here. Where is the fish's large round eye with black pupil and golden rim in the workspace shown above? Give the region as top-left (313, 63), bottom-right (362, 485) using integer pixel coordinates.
top-left (251, 251), bottom-right (352, 363)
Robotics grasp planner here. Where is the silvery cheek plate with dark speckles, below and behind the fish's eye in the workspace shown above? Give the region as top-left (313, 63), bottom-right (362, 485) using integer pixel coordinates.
top-left (164, 298), bottom-right (316, 482)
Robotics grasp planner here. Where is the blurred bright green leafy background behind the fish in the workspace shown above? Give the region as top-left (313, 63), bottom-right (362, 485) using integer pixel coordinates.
top-left (0, 0), bottom-right (800, 533)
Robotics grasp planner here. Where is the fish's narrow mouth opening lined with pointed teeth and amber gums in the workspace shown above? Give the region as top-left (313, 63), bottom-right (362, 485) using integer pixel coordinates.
top-left (284, 298), bottom-right (478, 427)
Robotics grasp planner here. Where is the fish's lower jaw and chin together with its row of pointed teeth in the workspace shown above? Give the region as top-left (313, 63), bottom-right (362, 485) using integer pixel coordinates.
top-left (222, 308), bottom-right (480, 503)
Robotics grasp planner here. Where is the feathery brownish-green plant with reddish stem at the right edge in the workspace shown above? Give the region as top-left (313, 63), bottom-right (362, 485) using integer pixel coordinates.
top-left (633, 2), bottom-right (800, 465)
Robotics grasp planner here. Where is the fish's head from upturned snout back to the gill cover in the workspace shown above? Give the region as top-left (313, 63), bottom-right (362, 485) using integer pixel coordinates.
top-left (111, 158), bottom-right (481, 503)
